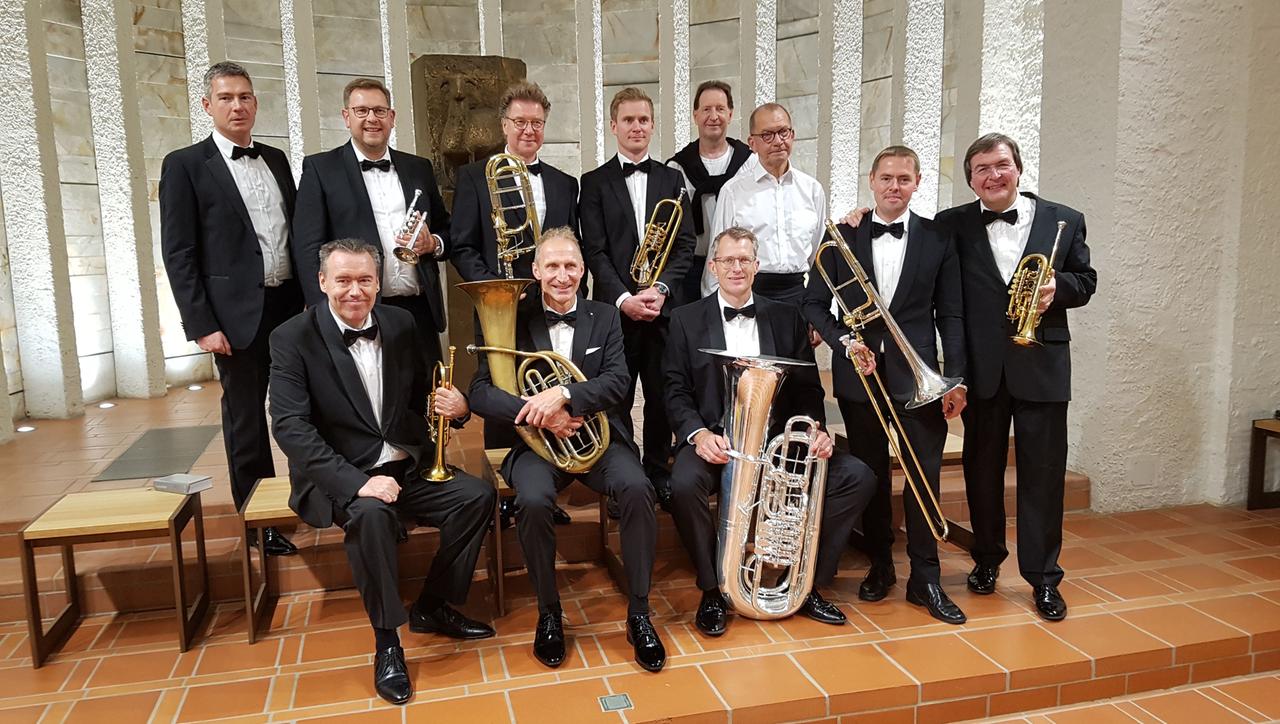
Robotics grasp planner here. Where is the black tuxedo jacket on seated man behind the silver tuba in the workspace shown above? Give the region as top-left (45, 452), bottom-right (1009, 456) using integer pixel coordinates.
top-left (664, 294), bottom-right (826, 449)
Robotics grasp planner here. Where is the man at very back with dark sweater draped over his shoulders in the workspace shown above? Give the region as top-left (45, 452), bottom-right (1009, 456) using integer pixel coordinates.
top-left (667, 81), bottom-right (751, 302)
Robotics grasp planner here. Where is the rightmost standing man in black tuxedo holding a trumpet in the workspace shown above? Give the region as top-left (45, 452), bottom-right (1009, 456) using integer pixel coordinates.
top-left (937, 133), bottom-right (1098, 620)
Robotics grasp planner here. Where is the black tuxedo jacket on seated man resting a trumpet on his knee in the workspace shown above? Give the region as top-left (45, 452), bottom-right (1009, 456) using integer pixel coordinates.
top-left (270, 302), bottom-right (430, 528)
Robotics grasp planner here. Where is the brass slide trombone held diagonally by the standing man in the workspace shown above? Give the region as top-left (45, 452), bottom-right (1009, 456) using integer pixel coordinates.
top-left (814, 221), bottom-right (974, 550)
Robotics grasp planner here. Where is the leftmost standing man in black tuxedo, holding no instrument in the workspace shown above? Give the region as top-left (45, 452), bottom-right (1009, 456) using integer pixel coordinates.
top-left (160, 63), bottom-right (302, 555)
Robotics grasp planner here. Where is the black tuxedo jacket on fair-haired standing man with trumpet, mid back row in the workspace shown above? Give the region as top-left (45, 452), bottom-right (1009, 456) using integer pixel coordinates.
top-left (577, 156), bottom-right (698, 309)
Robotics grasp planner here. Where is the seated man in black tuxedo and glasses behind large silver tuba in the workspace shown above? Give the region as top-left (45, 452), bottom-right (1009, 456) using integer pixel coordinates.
top-left (666, 226), bottom-right (876, 636)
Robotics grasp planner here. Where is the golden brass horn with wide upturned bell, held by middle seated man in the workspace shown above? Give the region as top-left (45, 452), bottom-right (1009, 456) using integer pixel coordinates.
top-left (458, 279), bottom-right (609, 475)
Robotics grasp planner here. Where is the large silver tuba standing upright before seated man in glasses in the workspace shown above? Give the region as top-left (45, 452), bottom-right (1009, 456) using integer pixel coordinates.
top-left (700, 349), bottom-right (827, 619)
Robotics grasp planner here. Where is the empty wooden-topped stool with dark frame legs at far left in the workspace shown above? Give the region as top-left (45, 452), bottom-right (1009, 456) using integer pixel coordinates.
top-left (20, 487), bottom-right (209, 669)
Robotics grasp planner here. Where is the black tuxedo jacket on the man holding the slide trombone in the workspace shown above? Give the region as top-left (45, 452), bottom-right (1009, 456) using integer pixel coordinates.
top-left (804, 214), bottom-right (968, 402)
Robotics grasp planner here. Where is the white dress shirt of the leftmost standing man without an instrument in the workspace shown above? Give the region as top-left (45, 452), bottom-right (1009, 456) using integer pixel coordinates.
top-left (214, 129), bottom-right (293, 287)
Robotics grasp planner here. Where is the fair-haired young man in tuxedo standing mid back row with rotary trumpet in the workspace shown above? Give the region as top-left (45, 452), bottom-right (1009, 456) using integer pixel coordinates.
top-left (579, 83), bottom-right (695, 498)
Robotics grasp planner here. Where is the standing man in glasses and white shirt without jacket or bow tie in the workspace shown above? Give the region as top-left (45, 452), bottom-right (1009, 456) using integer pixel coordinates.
top-left (703, 104), bottom-right (827, 304)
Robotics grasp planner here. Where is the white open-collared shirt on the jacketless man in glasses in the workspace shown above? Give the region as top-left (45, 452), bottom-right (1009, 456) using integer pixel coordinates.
top-left (703, 159), bottom-right (827, 294)
